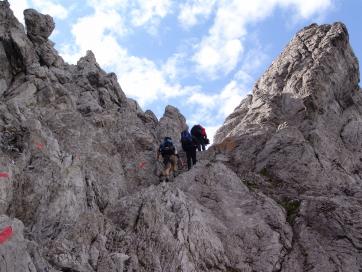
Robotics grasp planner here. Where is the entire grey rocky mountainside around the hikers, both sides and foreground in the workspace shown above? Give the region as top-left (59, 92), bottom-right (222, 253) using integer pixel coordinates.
top-left (0, 1), bottom-right (362, 272)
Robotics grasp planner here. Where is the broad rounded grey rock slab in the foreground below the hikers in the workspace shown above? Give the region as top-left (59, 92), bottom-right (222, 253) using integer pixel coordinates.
top-left (105, 163), bottom-right (291, 271)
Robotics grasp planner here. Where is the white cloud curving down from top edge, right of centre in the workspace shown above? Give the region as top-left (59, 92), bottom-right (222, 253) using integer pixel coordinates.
top-left (192, 0), bottom-right (332, 78)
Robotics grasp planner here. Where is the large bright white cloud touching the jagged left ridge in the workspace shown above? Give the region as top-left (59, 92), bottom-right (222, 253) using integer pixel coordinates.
top-left (61, 5), bottom-right (185, 106)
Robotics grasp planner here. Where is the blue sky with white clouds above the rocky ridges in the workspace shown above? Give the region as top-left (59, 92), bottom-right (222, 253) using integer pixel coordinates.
top-left (9, 0), bottom-right (362, 142)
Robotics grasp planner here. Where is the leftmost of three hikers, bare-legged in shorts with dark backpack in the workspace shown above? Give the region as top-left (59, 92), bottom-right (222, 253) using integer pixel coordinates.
top-left (157, 137), bottom-right (182, 181)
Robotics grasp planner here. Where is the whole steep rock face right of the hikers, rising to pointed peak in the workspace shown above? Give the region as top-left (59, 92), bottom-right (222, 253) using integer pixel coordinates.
top-left (214, 23), bottom-right (362, 271)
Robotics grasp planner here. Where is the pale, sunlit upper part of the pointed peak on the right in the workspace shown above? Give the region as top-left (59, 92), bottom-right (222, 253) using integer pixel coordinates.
top-left (215, 23), bottom-right (359, 143)
